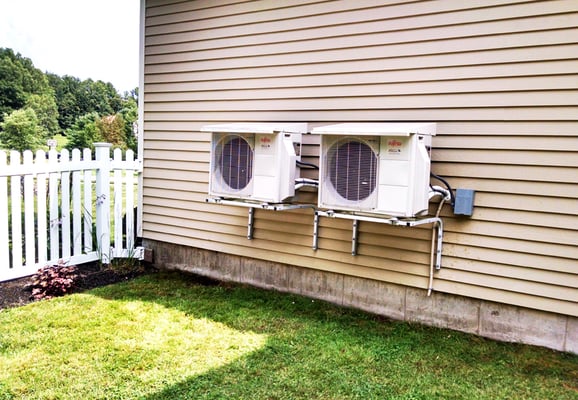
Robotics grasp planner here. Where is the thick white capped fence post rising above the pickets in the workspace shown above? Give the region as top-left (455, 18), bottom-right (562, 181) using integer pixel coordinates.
top-left (94, 143), bottom-right (112, 264)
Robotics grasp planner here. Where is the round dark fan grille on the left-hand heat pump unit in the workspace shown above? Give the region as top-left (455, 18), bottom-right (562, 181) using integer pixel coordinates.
top-left (216, 136), bottom-right (253, 190)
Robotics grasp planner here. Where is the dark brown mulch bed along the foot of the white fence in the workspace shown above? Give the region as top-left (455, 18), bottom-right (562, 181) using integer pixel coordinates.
top-left (0, 263), bottom-right (151, 310)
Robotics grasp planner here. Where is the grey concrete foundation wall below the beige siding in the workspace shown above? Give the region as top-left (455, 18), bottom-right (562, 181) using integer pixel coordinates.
top-left (144, 240), bottom-right (578, 354)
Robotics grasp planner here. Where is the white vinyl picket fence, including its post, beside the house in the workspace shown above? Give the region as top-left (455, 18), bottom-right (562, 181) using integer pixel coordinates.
top-left (0, 143), bottom-right (142, 281)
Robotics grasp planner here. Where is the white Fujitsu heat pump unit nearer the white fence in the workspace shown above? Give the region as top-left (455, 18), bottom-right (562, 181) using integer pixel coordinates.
top-left (202, 123), bottom-right (307, 203)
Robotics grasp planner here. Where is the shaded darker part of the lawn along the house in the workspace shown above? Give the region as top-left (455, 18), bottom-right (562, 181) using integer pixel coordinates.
top-left (92, 273), bottom-right (578, 400)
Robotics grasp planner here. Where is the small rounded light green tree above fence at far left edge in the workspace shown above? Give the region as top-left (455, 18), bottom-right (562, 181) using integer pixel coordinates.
top-left (0, 108), bottom-right (43, 152)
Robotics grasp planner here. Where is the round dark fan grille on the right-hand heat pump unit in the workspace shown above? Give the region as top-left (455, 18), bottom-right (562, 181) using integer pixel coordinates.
top-left (327, 139), bottom-right (378, 201)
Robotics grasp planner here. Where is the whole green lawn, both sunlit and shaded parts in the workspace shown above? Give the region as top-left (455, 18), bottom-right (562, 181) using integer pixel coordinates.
top-left (0, 274), bottom-right (578, 400)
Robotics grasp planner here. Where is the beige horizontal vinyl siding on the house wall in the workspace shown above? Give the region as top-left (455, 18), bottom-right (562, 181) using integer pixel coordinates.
top-left (143, 0), bottom-right (578, 316)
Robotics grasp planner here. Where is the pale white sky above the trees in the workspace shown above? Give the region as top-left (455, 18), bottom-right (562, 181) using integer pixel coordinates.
top-left (0, 0), bottom-right (140, 94)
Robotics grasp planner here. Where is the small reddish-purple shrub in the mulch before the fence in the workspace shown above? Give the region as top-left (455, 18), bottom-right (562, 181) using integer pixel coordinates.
top-left (30, 263), bottom-right (80, 300)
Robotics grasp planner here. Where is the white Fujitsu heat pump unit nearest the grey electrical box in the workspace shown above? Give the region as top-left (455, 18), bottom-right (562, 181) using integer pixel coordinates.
top-left (312, 123), bottom-right (436, 218)
